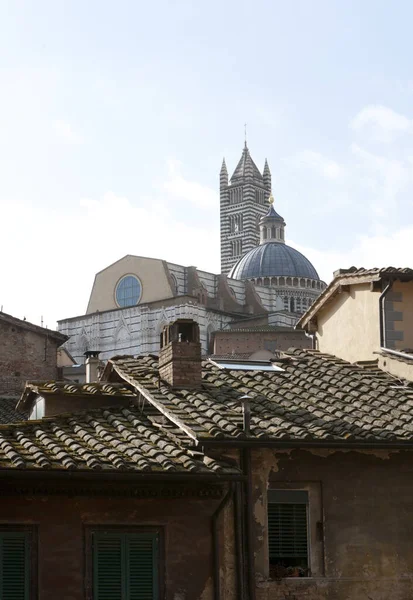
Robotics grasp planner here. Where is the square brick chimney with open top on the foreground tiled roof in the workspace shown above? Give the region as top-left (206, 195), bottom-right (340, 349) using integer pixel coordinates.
top-left (159, 319), bottom-right (202, 389)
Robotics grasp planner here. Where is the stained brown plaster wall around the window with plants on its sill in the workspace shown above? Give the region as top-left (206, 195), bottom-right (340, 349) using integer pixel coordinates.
top-left (249, 450), bottom-right (413, 600)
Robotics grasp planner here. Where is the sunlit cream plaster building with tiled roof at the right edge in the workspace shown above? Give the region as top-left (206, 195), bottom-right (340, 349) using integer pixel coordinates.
top-left (297, 267), bottom-right (413, 379)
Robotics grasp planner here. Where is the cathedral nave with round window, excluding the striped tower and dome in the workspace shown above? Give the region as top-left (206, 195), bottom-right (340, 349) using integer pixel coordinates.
top-left (59, 256), bottom-right (297, 363)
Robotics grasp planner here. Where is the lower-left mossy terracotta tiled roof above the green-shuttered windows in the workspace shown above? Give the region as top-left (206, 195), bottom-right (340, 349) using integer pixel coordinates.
top-left (0, 407), bottom-right (238, 476)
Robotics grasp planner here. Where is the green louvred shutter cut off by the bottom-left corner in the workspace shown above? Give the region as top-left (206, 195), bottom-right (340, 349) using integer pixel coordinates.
top-left (0, 531), bottom-right (30, 600)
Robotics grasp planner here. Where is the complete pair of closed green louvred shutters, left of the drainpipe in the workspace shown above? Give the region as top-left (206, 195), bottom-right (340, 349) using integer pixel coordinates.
top-left (92, 530), bottom-right (159, 600)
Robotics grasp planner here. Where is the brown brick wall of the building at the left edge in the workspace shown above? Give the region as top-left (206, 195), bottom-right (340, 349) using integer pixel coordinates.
top-left (0, 321), bottom-right (57, 396)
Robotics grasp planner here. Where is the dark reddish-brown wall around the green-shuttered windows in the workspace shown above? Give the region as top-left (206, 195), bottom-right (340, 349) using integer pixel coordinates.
top-left (0, 484), bottom-right (236, 600)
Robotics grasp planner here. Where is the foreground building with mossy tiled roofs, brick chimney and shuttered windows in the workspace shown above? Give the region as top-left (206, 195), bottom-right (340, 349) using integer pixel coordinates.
top-left (0, 320), bottom-right (413, 600)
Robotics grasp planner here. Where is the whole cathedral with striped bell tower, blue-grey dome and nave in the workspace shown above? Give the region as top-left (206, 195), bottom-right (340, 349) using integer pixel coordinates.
top-left (58, 144), bottom-right (325, 364)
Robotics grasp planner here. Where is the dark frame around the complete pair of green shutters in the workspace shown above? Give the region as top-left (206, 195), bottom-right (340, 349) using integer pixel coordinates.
top-left (83, 524), bottom-right (165, 600)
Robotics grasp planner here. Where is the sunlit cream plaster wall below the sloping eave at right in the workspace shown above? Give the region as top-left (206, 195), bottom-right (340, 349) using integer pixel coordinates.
top-left (317, 283), bottom-right (380, 362)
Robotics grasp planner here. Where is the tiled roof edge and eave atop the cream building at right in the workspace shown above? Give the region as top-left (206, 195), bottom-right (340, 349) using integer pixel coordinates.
top-left (296, 267), bottom-right (413, 329)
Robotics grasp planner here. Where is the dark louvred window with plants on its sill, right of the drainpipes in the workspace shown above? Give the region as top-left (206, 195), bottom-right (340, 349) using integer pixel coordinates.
top-left (268, 490), bottom-right (309, 577)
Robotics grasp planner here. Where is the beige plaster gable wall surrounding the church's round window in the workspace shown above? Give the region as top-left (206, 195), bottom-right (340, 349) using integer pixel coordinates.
top-left (86, 255), bottom-right (174, 314)
